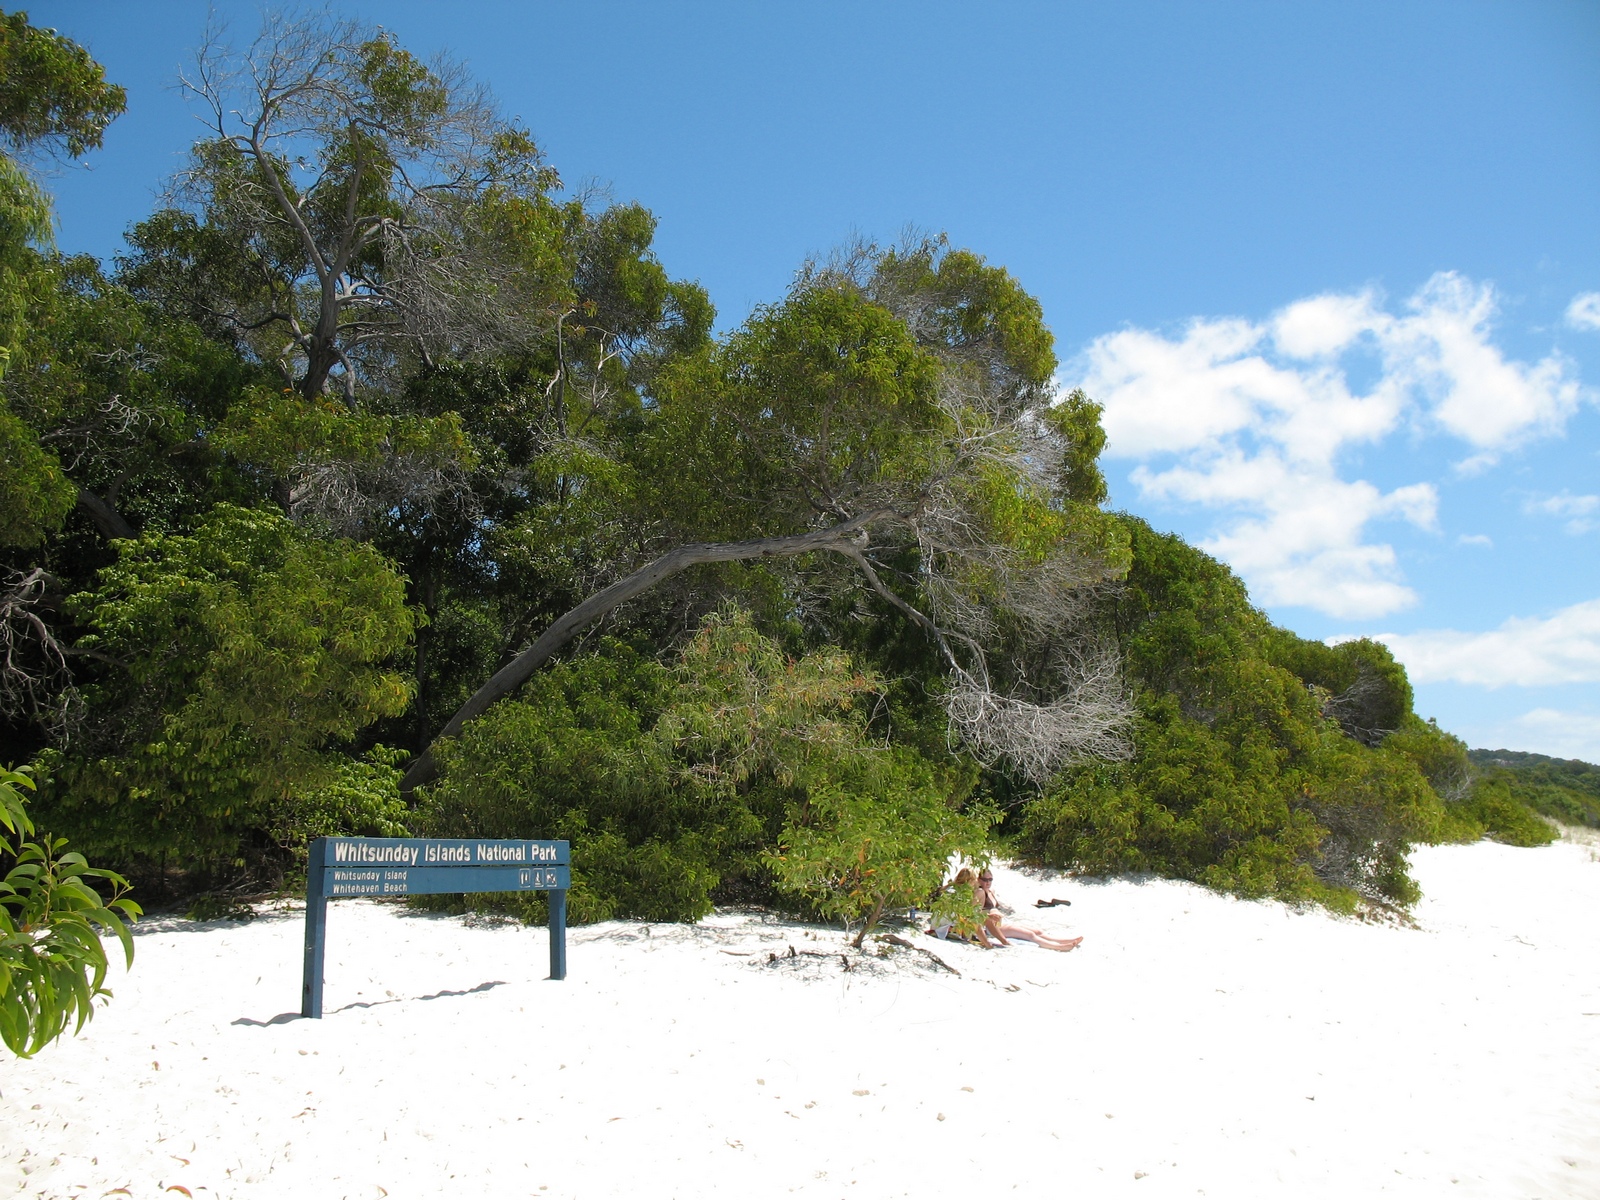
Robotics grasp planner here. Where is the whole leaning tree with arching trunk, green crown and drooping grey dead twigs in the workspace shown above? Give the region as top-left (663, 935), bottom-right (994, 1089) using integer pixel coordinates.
top-left (405, 240), bottom-right (1130, 787)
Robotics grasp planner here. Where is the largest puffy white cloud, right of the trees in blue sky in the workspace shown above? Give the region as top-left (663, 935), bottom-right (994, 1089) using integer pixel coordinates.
top-left (1070, 272), bottom-right (1582, 618)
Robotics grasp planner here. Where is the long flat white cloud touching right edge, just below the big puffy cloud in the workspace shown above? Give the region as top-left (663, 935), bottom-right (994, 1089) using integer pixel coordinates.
top-left (1374, 600), bottom-right (1600, 688)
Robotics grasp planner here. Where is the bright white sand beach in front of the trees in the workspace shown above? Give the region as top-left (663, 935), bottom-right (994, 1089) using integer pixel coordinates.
top-left (0, 842), bottom-right (1600, 1200)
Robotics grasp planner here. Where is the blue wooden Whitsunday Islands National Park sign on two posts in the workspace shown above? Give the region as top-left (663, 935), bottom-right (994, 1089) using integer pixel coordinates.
top-left (301, 837), bottom-right (573, 1018)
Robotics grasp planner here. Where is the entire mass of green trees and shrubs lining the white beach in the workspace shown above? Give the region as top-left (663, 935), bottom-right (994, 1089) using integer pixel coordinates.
top-left (0, 7), bottom-right (1555, 938)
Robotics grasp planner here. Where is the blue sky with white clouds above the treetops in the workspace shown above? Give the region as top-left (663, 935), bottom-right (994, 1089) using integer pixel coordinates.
top-left (29, 0), bottom-right (1600, 762)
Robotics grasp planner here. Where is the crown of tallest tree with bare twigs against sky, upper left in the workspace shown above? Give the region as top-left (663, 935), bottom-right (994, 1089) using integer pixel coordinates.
top-left (116, 13), bottom-right (557, 405)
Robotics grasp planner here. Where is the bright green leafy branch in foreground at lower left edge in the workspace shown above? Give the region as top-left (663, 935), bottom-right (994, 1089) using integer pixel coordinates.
top-left (0, 770), bottom-right (139, 1058)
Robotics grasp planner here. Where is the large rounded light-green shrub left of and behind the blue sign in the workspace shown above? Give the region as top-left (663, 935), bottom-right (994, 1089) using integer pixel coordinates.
top-left (38, 504), bottom-right (414, 874)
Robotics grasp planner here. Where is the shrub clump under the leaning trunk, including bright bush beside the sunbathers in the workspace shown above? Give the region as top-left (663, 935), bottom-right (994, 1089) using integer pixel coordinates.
top-left (418, 610), bottom-right (987, 928)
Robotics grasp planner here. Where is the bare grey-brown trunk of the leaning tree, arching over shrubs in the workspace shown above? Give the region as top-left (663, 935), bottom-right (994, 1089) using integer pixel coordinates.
top-left (400, 509), bottom-right (899, 795)
